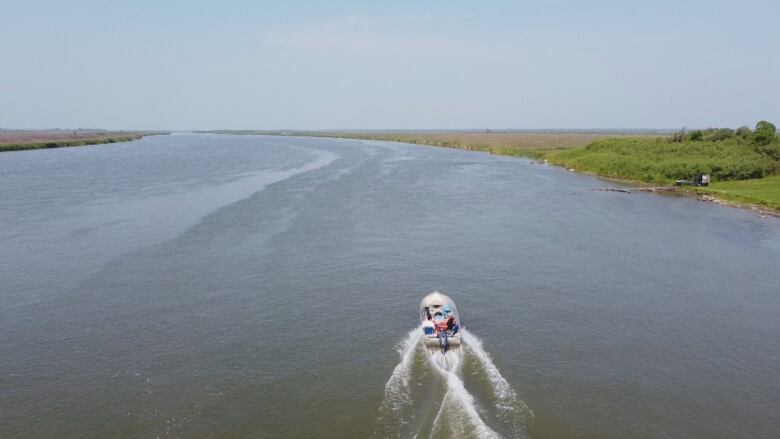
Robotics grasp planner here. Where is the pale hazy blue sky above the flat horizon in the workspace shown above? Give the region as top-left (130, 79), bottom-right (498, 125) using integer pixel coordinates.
top-left (0, 0), bottom-right (780, 130)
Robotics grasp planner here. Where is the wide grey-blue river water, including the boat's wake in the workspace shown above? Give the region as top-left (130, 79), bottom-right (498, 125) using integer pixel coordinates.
top-left (0, 134), bottom-right (780, 439)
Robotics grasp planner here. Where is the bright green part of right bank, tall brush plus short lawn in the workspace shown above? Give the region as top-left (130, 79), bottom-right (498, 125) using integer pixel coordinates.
top-left (546, 137), bottom-right (780, 216)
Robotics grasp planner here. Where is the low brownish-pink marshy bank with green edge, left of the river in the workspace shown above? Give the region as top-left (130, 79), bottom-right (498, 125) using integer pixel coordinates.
top-left (0, 130), bottom-right (168, 152)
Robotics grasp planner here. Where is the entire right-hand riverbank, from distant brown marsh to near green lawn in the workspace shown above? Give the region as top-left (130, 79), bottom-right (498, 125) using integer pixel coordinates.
top-left (206, 127), bottom-right (780, 212)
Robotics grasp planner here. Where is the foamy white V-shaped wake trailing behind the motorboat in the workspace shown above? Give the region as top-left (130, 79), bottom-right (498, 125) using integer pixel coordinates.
top-left (374, 328), bottom-right (533, 438)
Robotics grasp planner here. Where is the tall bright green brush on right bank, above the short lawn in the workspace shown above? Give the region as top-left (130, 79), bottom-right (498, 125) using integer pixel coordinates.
top-left (547, 138), bottom-right (780, 184)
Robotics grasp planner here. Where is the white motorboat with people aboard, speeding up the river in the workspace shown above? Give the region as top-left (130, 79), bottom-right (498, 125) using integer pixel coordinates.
top-left (420, 291), bottom-right (462, 354)
